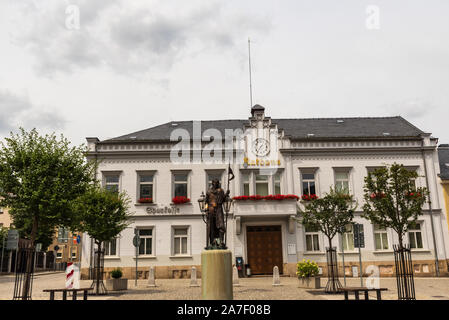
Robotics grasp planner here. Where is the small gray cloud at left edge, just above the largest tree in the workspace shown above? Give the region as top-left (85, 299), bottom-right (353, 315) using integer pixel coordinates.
top-left (0, 90), bottom-right (65, 134)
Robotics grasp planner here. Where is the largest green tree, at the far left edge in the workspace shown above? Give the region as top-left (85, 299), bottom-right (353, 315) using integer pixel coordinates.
top-left (0, 128), bottom-right (95, 299)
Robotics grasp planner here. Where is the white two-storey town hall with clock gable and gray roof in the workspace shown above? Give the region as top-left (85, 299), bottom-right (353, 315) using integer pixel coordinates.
top-left (82, 105), bottom-right (449, 278)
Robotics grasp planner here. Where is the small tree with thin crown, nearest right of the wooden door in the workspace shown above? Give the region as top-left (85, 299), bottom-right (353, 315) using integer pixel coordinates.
top-left (300, 188), bottom-right (357, 292)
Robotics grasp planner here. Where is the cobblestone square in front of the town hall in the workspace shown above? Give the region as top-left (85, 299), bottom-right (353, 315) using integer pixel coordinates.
top-left (0, 272), bottom-right (449, 300)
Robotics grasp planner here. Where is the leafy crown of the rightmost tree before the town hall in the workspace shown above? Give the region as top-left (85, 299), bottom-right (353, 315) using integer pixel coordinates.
top-left (363, 163), bottom-right (428, 249)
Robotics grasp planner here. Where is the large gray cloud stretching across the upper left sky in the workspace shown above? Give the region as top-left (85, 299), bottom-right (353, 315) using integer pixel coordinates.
top-left (13, 0), bottom-right (271, 76)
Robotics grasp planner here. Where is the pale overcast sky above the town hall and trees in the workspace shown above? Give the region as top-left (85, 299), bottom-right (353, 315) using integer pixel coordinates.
top-left (0, 0), bottom-right (449, 144)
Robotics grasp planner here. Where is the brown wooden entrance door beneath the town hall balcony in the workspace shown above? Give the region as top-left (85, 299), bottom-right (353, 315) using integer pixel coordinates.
top-left (246, 226), bottom-right (283, 274)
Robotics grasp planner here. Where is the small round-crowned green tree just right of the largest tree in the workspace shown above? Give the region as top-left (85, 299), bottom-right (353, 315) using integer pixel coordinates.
top-left (75, 185), bottom-right (130, 294)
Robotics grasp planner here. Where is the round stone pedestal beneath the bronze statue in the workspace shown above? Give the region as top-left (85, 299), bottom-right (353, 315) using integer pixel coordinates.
top-left (201, 250), bottom-right (233, 300)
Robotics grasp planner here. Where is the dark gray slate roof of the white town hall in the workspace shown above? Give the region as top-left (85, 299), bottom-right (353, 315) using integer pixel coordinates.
top-left (103, 116), bottom-right (424, 142)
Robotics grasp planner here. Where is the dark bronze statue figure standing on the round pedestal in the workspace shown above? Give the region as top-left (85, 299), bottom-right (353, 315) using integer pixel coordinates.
top-left (205, 179), bottom-right (229, 249)
